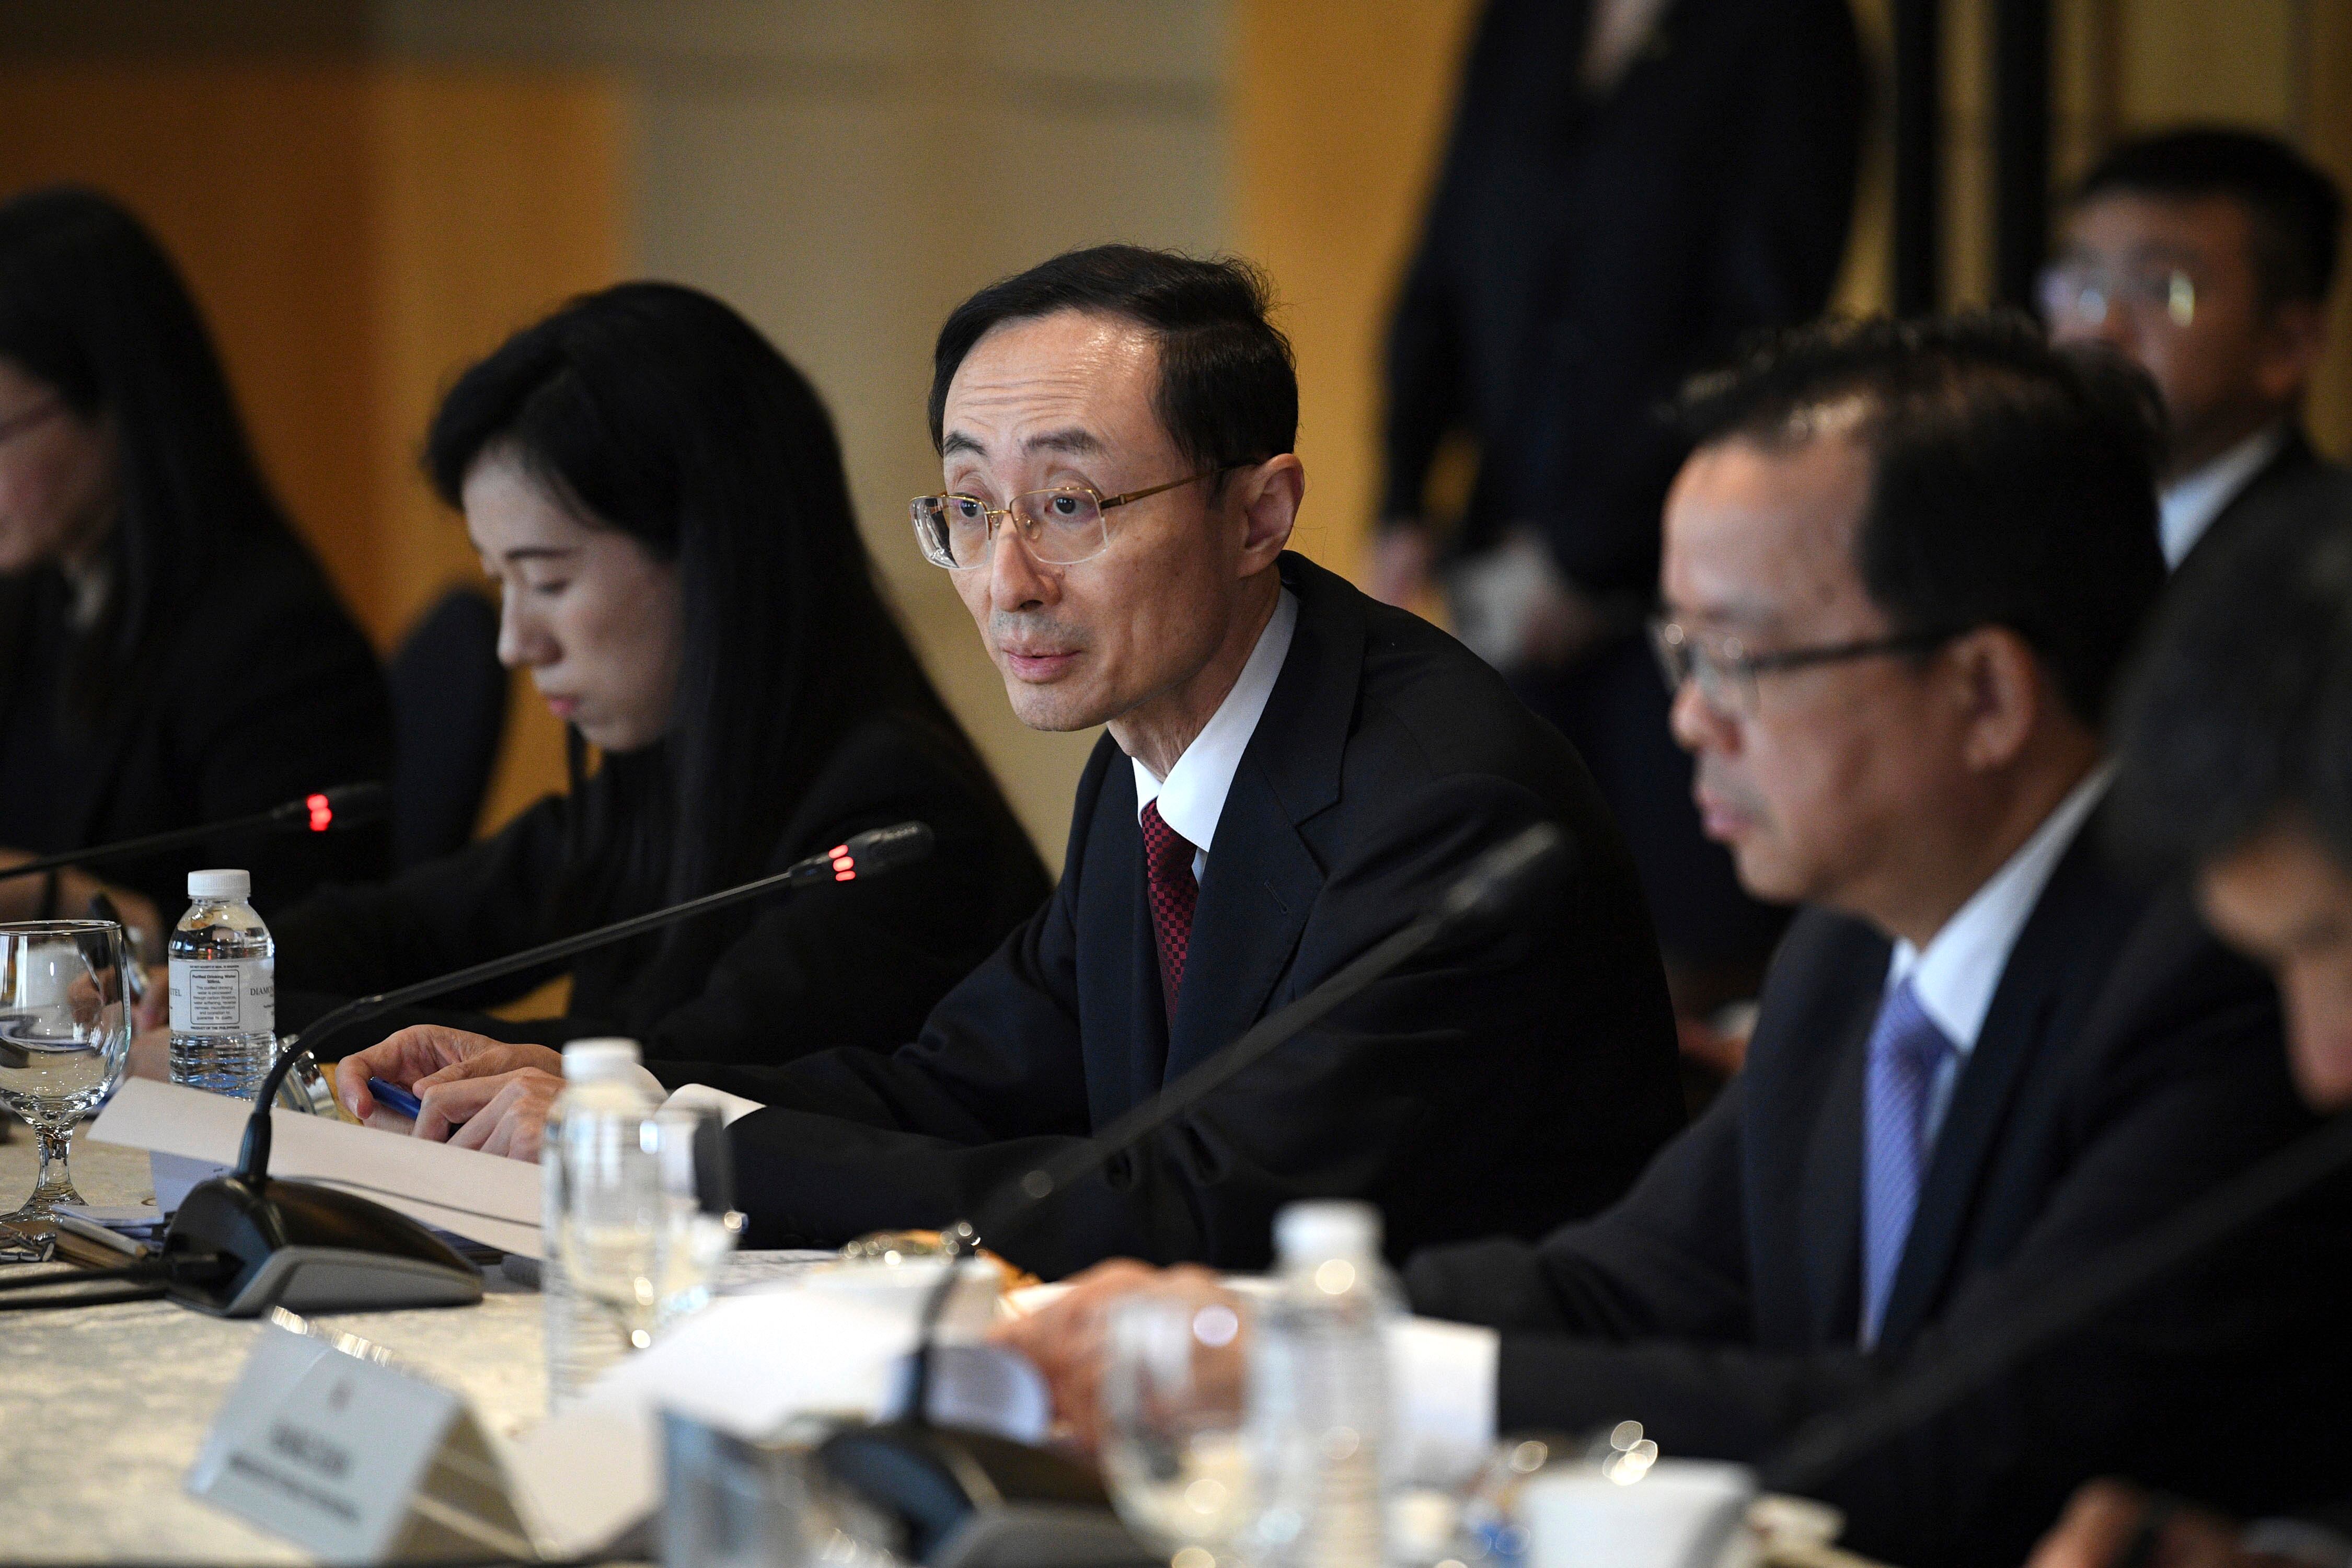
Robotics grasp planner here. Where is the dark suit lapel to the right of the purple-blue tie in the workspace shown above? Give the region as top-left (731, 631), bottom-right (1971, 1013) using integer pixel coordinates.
top-left (1880, 825), bottom-right (2103, 1347)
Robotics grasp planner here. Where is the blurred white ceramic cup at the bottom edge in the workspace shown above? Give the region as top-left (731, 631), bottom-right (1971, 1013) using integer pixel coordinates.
top-left (1519, 1460), bottom-right (1757, 1568)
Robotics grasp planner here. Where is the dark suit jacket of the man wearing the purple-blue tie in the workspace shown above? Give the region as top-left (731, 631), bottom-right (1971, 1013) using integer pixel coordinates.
top-left (1406, 818), bottom-right (2352, 1568)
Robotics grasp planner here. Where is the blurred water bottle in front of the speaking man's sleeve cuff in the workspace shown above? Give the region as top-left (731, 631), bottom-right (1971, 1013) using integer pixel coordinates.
top-left (539, 1039), bottom-right (663, 1411)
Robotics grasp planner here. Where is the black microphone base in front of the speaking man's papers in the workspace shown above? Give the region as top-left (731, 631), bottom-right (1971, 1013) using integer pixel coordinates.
top-left (163, 1175), bottom-right (482, 1317)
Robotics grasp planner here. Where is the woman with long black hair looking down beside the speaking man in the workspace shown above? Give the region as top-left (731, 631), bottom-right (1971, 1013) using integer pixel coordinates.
top-left (257, 282), bottom-right (1047, 1063)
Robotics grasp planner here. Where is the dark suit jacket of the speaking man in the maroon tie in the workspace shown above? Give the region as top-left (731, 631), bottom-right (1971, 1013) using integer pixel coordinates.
top-left (656, 555), bottom-right (1682, 1274)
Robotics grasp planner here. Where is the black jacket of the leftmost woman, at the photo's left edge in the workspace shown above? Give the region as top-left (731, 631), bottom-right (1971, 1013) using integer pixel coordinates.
top-left (0, 540), bottom-right (393, 921)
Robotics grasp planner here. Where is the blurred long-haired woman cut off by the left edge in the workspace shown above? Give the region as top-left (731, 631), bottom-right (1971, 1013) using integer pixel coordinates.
top-left (0, 188), bottom-right (393, 940)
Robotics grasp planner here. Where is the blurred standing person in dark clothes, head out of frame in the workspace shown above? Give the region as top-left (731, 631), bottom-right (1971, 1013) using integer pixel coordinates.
top-left (1371, 0), bottom-right (1865, 1067)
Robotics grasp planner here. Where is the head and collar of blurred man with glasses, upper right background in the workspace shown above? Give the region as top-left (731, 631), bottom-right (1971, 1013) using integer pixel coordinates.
top-left (2042, 129), bottom-right (2343, 567)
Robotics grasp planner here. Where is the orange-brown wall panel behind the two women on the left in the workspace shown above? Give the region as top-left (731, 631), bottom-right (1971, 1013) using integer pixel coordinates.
top-left (0, 59), bottom-right (626, 823)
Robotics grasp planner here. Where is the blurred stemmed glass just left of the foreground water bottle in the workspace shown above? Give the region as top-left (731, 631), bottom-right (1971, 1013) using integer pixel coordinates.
top-left (1103, 1281), bottom-right (1251, 1568)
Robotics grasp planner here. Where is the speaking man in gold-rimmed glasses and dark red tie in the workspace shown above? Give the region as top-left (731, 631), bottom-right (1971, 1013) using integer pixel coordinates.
top-left (339, 247), bottom-right (1682, 1274)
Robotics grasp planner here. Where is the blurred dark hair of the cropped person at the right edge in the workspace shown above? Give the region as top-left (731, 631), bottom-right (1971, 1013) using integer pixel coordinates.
top-left (2107, 477), bottom-right (2352, 872)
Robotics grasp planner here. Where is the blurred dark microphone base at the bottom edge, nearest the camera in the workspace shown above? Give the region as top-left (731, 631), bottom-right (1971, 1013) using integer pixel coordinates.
top-left (816, 1422), bottom-right (1160, 1568)
